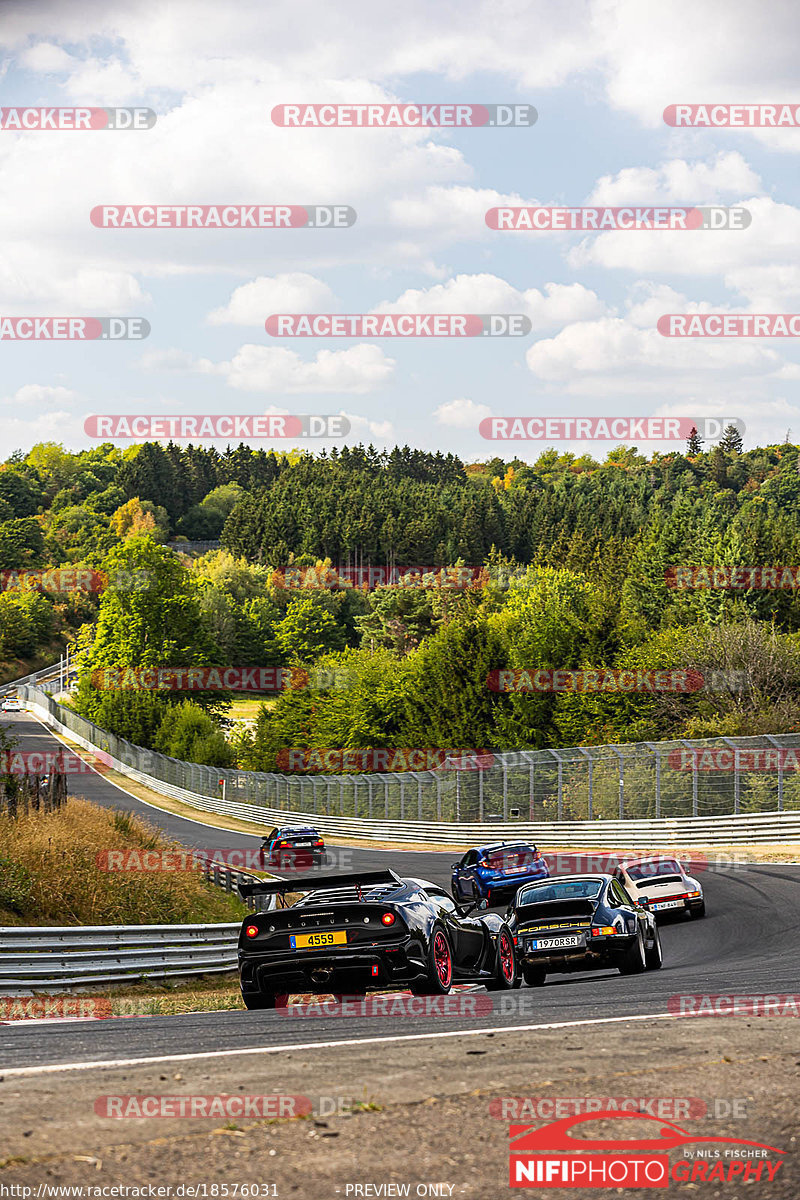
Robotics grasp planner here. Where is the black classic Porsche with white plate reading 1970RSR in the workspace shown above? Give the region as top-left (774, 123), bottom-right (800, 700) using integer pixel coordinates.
top-left (506, 875), bottom-right (661, 986)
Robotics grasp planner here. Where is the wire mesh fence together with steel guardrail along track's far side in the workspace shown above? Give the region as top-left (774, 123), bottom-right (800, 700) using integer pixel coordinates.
top-left (19, 688), bottom-right (800, 850)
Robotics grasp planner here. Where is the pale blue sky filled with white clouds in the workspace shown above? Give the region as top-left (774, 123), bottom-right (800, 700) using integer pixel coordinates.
top-left (0, 0), bottom-right (800, 461)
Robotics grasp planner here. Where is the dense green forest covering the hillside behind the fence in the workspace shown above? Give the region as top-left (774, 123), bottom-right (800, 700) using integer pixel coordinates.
top-left (0, 430), bottom-right (800, 768)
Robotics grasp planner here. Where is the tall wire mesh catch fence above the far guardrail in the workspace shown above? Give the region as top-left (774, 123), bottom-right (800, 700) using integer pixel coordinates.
top-left (19, 686), bottom-right (800, 824)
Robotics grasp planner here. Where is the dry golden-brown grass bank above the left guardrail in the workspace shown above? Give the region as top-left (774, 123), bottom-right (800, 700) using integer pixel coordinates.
top-left (0, 799), bottom-right (247, 925)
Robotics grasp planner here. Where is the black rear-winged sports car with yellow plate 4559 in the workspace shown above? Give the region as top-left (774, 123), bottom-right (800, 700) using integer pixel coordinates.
top-left (239, 870), bottom-right (517, 1008)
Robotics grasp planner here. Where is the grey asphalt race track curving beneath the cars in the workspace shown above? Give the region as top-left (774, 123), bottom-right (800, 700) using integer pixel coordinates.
top-left (0, 714), bottom-right (800, 1074)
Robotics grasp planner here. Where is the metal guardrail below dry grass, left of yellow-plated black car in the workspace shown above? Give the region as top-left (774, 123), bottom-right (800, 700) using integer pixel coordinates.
top-left (0, 922), bottom-right (241, 996)
